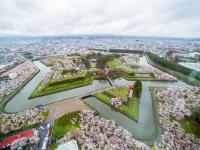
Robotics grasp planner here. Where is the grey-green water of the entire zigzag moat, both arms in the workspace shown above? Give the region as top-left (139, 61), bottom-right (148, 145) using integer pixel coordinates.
top-left (4, 61), bottom-right (189, 143)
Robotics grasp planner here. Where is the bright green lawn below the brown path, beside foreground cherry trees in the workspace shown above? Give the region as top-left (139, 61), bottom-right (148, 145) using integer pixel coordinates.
top-left (52, 111), bottom-right (80, 138)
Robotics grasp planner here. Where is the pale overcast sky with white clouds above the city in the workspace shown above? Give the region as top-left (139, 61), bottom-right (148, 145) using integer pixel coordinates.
top-left (0, 0), bottom-right (200, 37)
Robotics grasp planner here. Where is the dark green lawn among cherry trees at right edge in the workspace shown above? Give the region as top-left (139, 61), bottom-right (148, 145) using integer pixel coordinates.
top-left (180, 117), bottom-right (200, 138)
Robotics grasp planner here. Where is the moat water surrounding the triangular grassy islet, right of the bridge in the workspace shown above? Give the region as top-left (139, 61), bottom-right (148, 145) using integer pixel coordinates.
top-left (84, 78), bottom-right (188, 143)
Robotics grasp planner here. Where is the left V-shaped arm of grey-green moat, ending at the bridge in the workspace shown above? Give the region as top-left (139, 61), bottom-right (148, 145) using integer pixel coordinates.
top-left (4, 61), bottom-right (110, 113)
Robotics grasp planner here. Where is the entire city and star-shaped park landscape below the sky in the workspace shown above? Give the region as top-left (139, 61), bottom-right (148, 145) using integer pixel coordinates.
top-left (0, 35), bottom-right (200, 150)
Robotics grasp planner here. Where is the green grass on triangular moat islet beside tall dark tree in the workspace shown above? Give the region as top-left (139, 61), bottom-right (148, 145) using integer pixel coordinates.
top-left (93, 88), bottom-right (139, 120)
